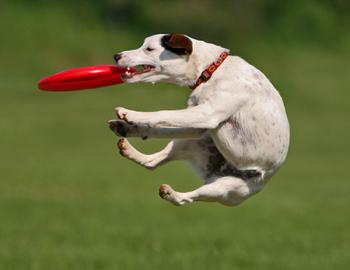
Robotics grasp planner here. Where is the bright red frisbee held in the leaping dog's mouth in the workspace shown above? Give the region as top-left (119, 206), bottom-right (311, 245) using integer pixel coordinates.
top-left (38, 65), bottom-right (133, 92)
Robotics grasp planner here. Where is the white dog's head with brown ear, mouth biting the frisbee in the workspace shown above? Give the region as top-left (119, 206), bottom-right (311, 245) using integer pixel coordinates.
top-left (114, 34), bottom-right (197, 85)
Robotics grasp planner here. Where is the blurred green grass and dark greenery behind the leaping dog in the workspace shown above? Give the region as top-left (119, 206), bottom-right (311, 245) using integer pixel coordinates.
top-left (0, 0), bottom-right (350, 270)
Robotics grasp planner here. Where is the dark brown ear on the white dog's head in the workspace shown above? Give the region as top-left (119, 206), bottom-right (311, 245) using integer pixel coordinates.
top-left (161, 34), bottom-right (192, 55)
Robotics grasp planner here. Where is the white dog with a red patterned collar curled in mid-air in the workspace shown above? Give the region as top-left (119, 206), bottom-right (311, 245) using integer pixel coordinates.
top-left (108, 34), bottom-right (290, 206)
